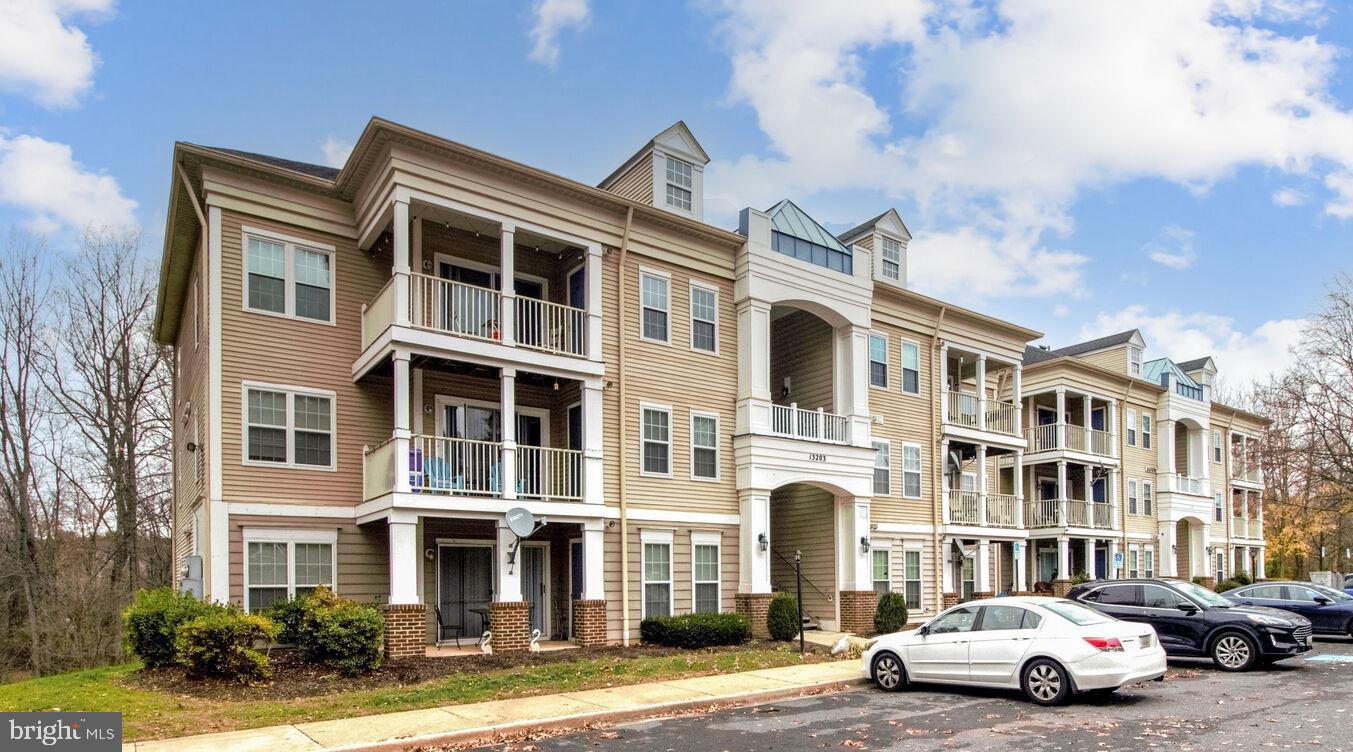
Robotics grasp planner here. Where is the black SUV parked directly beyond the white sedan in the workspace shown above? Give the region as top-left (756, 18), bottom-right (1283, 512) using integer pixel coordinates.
top-left (1068, 579), bottom-right (1311, 671)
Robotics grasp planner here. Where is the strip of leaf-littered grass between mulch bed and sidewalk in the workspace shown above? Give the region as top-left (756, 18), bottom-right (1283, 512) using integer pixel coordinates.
top-left (0, 645), bottom-right (820, 741)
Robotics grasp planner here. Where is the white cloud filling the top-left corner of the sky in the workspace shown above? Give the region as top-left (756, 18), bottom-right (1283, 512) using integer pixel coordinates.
top-left (0, 0), bottom-right (114, 107)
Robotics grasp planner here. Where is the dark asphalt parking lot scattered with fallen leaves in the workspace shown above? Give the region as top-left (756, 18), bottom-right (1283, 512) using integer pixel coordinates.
top-left (473, 638), bottom-right (1353, 752)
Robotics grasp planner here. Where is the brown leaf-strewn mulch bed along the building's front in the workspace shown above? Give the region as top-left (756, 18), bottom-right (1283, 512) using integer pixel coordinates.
top-left (126, 642), bottom-right (828, 702)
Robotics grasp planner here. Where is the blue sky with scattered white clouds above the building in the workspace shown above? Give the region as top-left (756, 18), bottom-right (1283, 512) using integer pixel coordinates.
top-left (0, 0), bottom-right (1353, 380)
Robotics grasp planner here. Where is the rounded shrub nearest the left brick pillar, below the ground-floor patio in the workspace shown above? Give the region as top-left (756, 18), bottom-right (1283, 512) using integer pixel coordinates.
top-left (298, 587), bottom-right (386, 676)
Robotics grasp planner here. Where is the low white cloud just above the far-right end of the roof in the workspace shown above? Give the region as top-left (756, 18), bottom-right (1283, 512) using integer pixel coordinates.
top-left (1080, 306), bottom-right (1306, 385)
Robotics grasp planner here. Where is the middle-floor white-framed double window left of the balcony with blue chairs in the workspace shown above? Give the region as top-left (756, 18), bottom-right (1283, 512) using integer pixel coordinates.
top-left (245, 384), bottom-right (334, 469)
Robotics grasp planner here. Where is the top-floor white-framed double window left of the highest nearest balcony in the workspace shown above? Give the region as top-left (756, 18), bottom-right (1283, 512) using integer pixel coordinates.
top-left (245, 229), bottom-right (334, 323)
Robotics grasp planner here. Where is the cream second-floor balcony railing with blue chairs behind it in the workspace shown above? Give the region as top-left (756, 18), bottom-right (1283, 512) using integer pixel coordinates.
top-left (363, 436), bottom-right (583, 502)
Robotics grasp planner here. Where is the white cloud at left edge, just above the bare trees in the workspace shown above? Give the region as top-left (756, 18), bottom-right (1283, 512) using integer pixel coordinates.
top-left (0, 135), bottom-right (137, 233)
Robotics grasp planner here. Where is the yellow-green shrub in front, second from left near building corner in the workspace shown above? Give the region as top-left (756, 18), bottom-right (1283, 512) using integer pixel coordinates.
top-left (175, 609), bottom-right (277, 682)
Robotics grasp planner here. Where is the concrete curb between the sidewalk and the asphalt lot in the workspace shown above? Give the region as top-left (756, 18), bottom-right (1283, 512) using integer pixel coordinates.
top-left (325, 678), bottom-right (869, 752)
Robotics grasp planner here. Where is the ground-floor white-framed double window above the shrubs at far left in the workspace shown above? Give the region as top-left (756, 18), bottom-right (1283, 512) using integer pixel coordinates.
top-left (245, 529), bottom-right (338, 611)
